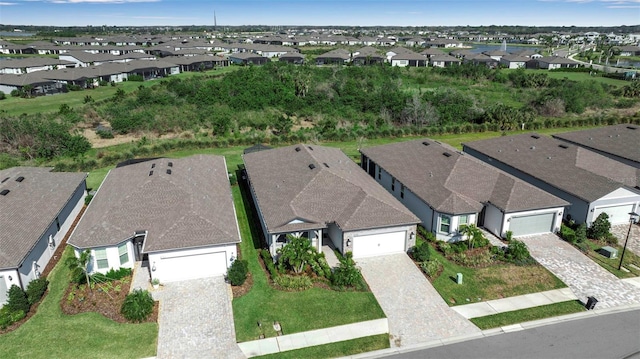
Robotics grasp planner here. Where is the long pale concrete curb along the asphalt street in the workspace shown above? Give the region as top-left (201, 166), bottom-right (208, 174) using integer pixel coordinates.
top-left (342, 304), bottom-right (640, 359)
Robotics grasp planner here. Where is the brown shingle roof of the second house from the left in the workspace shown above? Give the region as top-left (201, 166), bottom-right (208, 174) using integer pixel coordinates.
top-left (69, 155), bottom-right (240, 253)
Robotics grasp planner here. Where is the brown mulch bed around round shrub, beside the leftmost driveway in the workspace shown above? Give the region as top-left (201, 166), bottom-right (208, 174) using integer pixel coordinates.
top-left (60, 277), bottom-right (159, 323)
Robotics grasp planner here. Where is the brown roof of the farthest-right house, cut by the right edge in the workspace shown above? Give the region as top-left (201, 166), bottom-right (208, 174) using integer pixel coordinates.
top-left (553, 123), bottom-right (640, 168)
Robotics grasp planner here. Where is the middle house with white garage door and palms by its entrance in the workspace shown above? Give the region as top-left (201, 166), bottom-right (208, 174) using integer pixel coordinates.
top-left (243, 144), bottom-right (419, 258)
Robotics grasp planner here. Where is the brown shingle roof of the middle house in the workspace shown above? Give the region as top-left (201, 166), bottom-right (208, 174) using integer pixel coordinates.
top-left (244, 144), bottom-right (419, 233)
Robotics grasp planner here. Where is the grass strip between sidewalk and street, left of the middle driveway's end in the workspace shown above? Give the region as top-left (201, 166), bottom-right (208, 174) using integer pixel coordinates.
top-left (256, 334), bottom-right (389, 359)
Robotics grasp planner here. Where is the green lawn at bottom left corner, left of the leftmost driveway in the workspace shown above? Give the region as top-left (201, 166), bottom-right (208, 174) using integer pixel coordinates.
top-left (0, 248), bottom-right (158, 359)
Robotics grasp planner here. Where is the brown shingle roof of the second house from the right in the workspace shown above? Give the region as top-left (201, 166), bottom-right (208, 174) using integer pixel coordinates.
top-left (464, 133), bottom-right (640, 202)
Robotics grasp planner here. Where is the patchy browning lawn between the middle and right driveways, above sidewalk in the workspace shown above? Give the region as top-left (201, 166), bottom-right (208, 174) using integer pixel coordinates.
top-left (424, 245), bottom-right (566, 305)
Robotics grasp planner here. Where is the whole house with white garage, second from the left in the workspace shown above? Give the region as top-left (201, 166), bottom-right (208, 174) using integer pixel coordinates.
top-left (69, 155), bottom-right (240, 282)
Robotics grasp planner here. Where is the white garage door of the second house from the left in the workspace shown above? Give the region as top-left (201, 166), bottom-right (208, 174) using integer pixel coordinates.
top-left (161, 252), bottom-right (227, 282)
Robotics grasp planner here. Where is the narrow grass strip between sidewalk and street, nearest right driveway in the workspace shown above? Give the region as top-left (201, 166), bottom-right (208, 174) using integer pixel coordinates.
top-left (470, 300), bottom-right (586, 330)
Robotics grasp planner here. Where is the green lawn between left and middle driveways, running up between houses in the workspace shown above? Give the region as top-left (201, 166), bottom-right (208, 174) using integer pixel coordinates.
top-left (232, 186), bottom-right (388, 342)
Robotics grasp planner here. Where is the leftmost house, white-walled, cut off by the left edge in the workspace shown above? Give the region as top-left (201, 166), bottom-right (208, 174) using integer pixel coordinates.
top-left (0, 167), bottom-right (87, 306)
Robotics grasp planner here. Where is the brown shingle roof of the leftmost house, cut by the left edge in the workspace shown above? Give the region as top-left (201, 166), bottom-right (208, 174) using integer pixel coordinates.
top-left (0, 167), bottom-right (86, 269)
